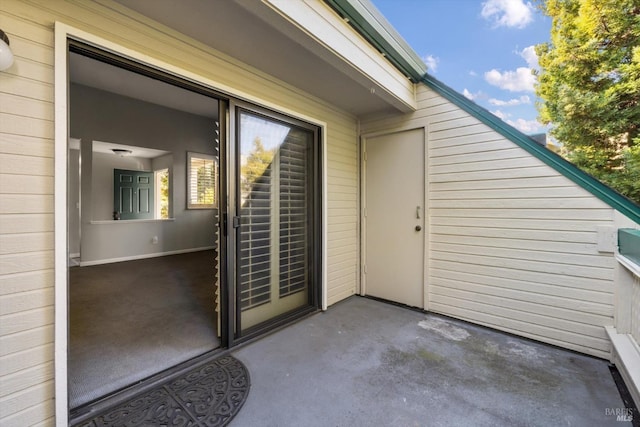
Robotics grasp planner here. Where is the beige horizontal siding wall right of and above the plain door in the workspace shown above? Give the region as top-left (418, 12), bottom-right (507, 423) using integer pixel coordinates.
top-left (362, 87), bottom-right (636, 357)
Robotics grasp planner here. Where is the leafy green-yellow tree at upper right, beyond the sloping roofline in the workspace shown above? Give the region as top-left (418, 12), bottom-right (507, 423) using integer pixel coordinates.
top-left (536, 0), bottom-right (640, 204)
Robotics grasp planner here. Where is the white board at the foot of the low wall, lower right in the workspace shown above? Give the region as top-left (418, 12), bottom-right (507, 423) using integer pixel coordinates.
top-left (605, 326), bottom-right (640, 405)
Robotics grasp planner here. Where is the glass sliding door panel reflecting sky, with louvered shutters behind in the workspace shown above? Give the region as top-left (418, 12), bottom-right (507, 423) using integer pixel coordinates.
top-left (237, 110), bottom-right (315, 331)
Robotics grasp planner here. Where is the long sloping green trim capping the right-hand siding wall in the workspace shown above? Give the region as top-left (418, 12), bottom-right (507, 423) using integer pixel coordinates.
top-left (422, 75), bottom-right (640, 223)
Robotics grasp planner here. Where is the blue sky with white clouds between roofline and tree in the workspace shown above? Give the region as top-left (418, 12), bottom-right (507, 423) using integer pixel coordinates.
top-left (371, 0), bottom-right (551, 134)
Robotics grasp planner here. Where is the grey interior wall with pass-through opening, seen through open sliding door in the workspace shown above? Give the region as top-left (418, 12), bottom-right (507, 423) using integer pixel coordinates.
top-left (70, 84), bottom-right (217, 265)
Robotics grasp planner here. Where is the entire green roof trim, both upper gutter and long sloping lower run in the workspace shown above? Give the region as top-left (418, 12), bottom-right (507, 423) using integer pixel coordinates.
top-left (324, 0), bottom-right (640, 227)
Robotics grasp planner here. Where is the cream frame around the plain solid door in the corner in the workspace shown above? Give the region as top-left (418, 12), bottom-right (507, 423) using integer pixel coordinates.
top-left (359, 126), bottom-right (431, 311)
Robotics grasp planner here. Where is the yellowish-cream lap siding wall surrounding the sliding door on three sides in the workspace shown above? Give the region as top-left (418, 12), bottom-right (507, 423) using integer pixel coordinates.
top-left (0, 0), bottom-right (358, 426)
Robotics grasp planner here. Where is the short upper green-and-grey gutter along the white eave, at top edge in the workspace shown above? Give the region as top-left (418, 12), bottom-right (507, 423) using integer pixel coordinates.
top-left (325, 0), bottom-right (427, 83)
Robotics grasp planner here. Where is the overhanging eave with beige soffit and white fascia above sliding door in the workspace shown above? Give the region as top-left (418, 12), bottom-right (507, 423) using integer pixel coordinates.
top-left (115, 0), bottom-right (415, 116)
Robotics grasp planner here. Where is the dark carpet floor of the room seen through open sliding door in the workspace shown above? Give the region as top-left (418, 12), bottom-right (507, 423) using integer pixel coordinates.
top-left (68, 251), bottom-right (219, 408)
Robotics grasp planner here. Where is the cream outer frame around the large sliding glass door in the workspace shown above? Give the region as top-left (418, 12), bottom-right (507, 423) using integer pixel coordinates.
top-left (53, 21), bottom-right (328, 426)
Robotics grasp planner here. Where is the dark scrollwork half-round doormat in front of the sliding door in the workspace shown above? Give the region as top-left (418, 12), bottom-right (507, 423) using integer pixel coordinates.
top-left (75, 356), bottom-right (251, 427)
